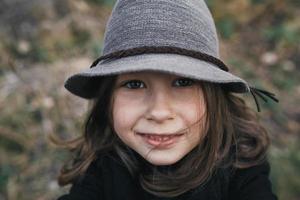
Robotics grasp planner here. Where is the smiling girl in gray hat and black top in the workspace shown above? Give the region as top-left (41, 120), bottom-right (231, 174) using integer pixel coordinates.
top-left (58, 0), bottom-right (277, 200)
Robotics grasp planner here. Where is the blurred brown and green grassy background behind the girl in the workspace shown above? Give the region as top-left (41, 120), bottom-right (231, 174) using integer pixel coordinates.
top-left (0, 0), bottom-right (300, 200)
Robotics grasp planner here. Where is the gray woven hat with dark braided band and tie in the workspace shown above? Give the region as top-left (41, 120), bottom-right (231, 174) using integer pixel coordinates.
top-left (65, 0), bottom-right (275, 111)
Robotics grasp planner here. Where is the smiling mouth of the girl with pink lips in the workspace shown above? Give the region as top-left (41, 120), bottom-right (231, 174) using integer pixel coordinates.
top-left (137, 133), bottom-right (184, 148)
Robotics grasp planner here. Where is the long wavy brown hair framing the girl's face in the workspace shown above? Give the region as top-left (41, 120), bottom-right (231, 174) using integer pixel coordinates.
top-left (53, 76), bottom-right (269, 197)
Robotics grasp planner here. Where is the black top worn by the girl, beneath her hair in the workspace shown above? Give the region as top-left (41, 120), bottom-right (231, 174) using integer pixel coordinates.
top-left (58, 152), bottom-right (277, 200)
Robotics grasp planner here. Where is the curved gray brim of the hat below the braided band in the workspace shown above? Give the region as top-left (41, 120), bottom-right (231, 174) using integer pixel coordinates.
top-left (64, 53), bottom-right (250, 99)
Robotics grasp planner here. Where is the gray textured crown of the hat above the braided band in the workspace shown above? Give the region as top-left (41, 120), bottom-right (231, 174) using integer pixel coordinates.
top-left (102, 0), bottom-right (219, 58)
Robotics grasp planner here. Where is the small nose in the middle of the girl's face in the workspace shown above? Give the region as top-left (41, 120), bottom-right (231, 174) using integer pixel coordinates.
top-left (146, 91), bottom-right (174, 123)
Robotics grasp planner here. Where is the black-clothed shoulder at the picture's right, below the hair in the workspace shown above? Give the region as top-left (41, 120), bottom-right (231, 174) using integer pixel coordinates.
top-left (228, 160), bottom-right (277, 200)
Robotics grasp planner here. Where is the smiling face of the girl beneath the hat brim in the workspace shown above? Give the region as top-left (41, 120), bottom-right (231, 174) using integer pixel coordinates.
top-left (112, 72), bottom-right (206, 165)
